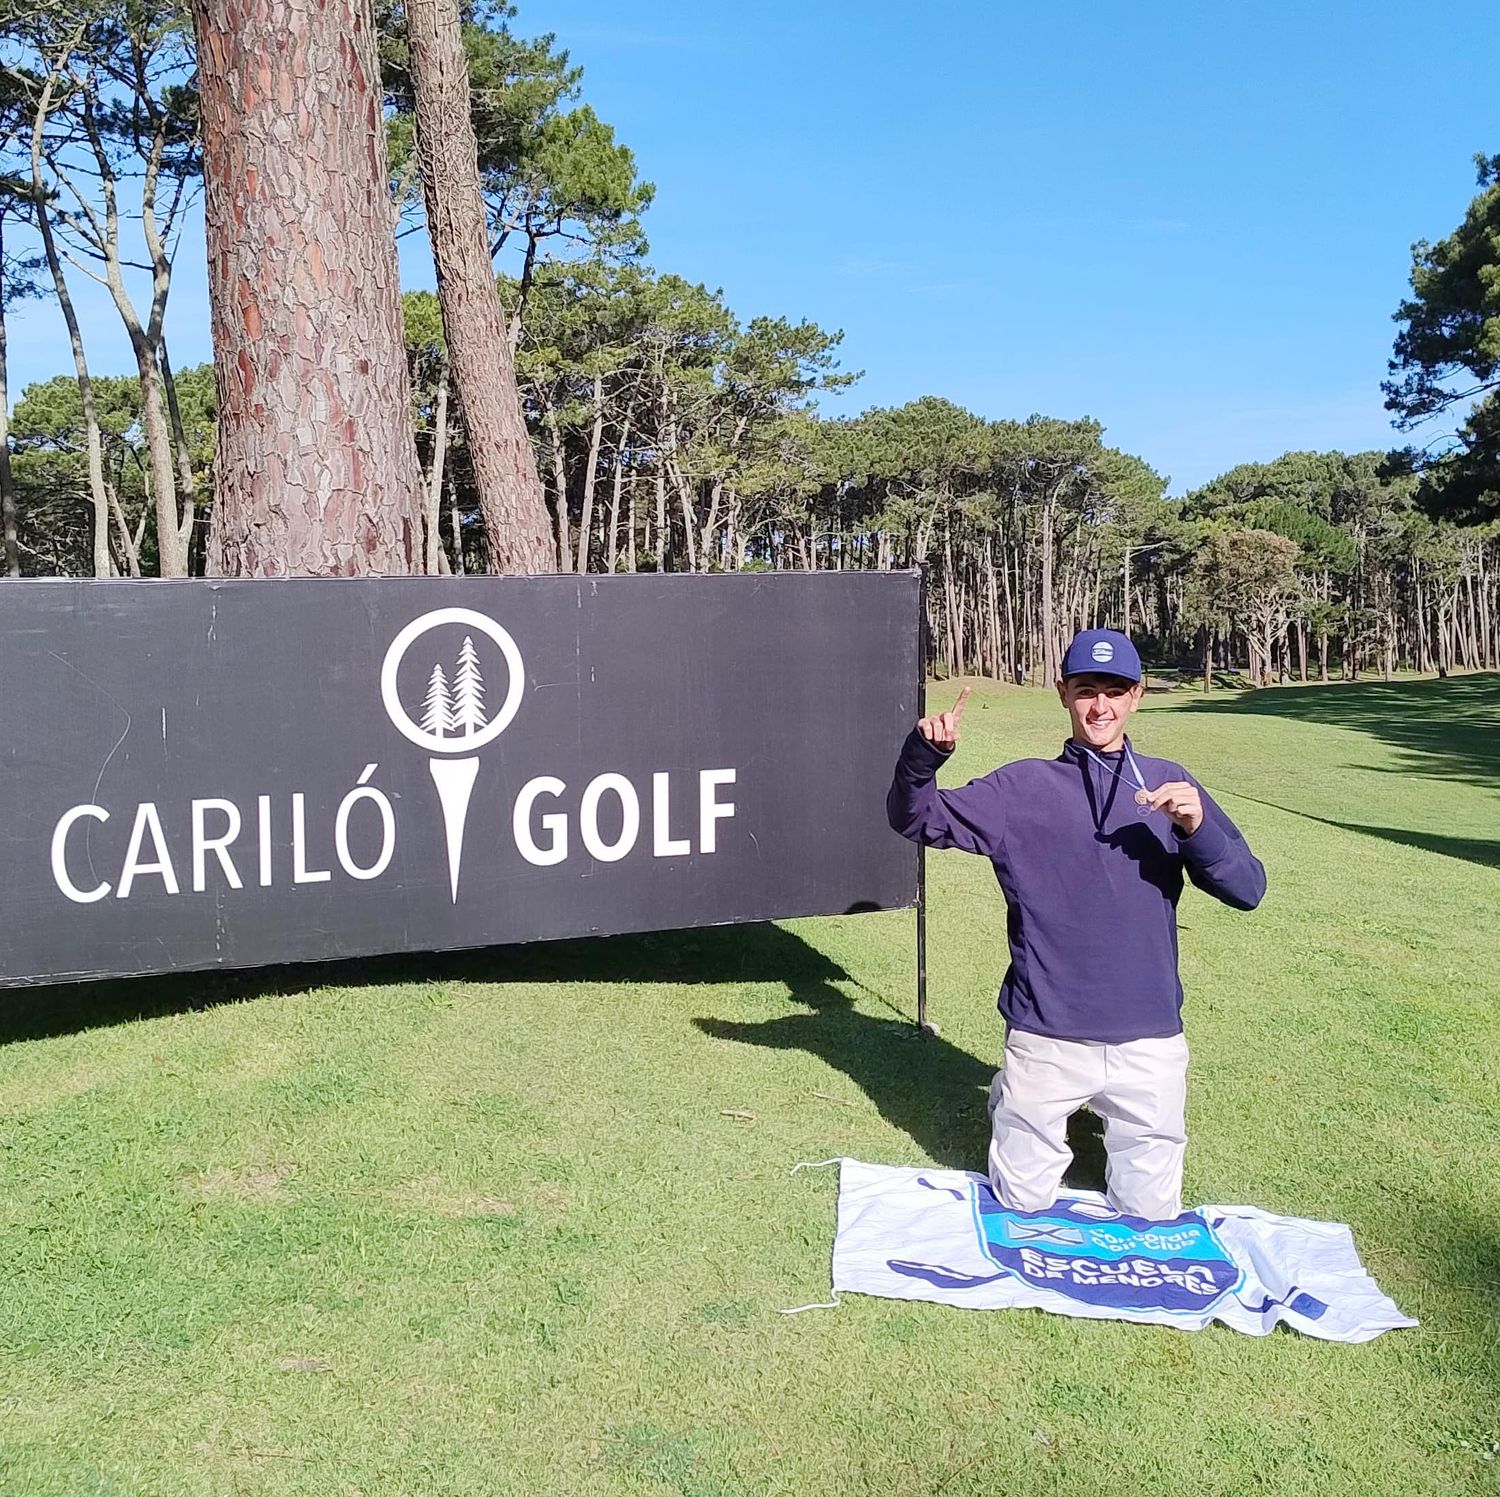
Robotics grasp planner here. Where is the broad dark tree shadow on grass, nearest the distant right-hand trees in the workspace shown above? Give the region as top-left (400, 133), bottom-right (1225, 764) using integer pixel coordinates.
top-left (1184, 675), bottom-right (1500, 789)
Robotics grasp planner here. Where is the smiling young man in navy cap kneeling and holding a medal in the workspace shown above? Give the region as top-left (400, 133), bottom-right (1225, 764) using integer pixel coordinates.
top-left (887, 629), bottom-right (1266, 1221)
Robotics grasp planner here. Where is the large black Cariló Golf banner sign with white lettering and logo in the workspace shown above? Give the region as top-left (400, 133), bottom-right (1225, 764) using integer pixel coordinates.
top-left (0, 573), bottom-right (918, 984)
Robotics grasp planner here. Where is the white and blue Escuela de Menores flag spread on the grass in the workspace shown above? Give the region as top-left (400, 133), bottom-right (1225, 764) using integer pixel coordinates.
top-left (798, 1160), bottom-right (1416, 1341)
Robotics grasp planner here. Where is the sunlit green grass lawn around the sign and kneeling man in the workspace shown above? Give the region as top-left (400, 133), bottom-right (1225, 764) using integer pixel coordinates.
top-left (0, 677), bottom-right (1500, 1497)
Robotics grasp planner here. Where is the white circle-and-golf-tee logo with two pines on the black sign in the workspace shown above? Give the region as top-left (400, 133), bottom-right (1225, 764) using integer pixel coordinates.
top-left (380, 608), bottom-right (527, 905)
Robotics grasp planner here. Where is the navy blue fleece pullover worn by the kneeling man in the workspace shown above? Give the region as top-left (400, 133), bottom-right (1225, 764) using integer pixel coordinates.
top-left (887, 729), bottom-right (1266, 1044)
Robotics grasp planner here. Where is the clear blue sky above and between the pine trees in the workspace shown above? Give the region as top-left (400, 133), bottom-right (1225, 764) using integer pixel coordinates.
top-left (11, 0), bottom-right (1500, 492)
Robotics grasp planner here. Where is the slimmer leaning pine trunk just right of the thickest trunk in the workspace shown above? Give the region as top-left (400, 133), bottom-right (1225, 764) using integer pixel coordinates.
top-left (407, 0), bottom-right (554, 573)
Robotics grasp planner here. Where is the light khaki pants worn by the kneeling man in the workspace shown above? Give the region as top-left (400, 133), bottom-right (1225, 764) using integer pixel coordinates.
top-left (990, 1029), bottom-right (1188, 1221)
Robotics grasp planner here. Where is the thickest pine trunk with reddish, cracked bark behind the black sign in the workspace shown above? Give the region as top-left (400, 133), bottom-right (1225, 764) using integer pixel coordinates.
top-left (194, 0), bottom-right (426, 576)
